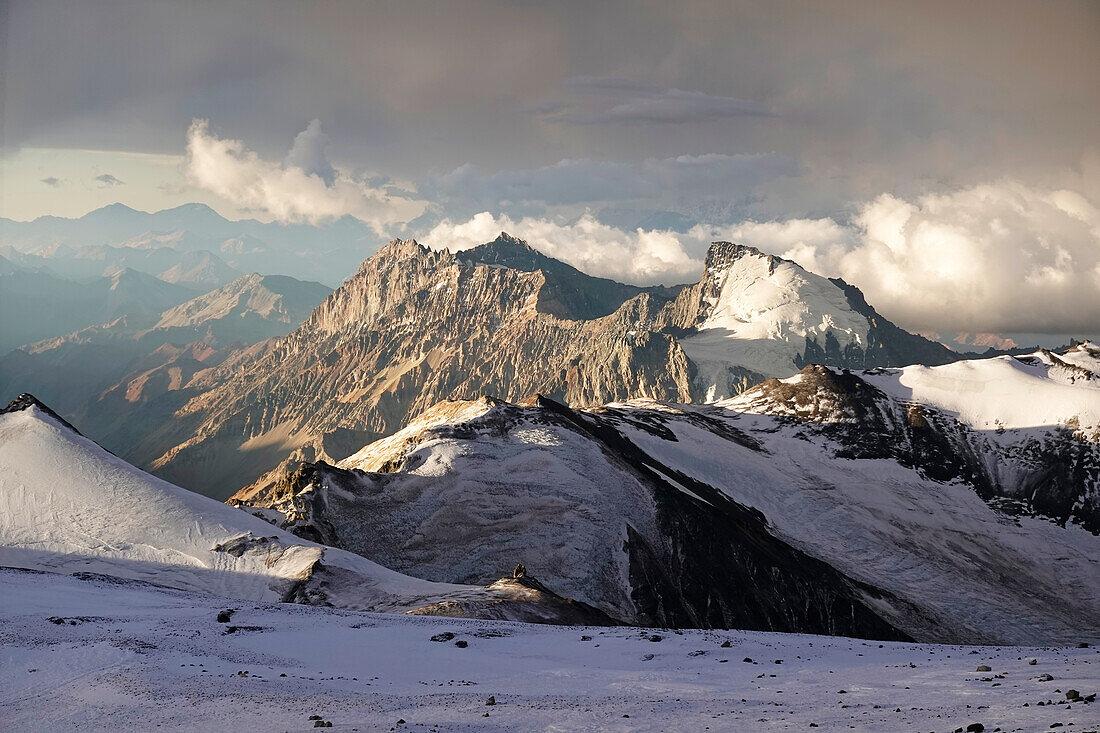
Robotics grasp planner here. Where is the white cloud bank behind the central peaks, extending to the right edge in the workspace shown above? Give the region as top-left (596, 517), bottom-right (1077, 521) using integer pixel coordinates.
top-left (426, 180), bottom-right (1100, 336)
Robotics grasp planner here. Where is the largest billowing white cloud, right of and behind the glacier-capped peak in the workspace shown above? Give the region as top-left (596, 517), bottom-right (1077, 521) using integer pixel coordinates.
top-left (714, 180), bottom-right (1100, 335)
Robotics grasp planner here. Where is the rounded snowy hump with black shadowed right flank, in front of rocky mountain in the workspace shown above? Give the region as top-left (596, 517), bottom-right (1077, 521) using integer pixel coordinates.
top-left (231, 398), bottom-right (928, 638)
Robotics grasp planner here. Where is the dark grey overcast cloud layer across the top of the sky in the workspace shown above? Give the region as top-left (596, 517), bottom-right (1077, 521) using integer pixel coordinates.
top-left (0, 0), bottom-right (1100, 215)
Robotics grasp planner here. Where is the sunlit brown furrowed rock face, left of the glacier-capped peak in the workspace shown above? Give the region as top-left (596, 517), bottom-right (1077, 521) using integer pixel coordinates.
top-left (147, 241), bottom-right (695, 496)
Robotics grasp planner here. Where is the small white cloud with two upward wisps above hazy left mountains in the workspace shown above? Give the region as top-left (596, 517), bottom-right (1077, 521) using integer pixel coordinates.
top-left (184, 120), bottom-right (424, 228)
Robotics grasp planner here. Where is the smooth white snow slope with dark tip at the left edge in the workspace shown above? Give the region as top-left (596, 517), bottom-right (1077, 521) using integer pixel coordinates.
top-left (0, 404), bottom-right (474, 610)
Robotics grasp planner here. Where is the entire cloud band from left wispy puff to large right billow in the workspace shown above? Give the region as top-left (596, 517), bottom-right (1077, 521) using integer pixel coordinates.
top-left (176, 120), bottom-right (1100, 333)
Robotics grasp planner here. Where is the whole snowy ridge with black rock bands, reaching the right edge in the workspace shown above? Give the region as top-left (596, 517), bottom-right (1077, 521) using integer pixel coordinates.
top-left (231, 343), bottom-right (1100, 643)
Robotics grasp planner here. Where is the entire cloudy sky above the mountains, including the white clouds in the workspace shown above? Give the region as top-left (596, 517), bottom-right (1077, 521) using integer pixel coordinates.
top-left (0, 0), bottom-right (1100, 330)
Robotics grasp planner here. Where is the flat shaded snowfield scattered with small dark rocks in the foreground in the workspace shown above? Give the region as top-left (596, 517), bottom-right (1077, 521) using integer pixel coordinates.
top-left (0, 569), bottom-right (1100, 732)
